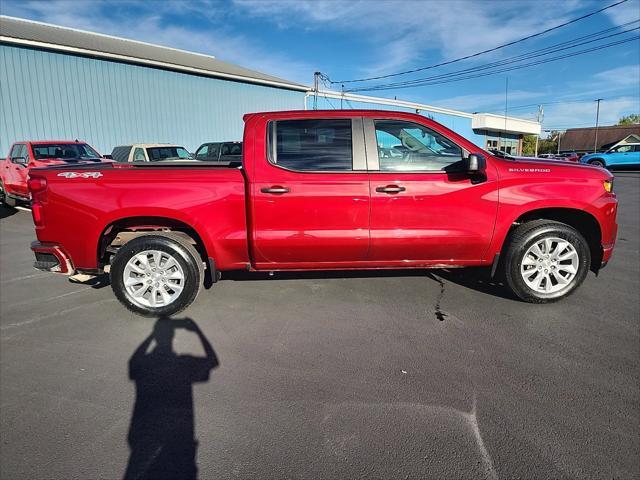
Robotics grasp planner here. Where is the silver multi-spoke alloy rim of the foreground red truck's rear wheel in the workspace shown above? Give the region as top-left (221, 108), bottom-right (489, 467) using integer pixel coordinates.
top-left (122, 250), bottom-right (185, 308)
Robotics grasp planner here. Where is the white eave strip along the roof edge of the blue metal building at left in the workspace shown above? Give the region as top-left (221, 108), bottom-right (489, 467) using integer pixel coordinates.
top-left (0, 35), bottom-right (309, 92)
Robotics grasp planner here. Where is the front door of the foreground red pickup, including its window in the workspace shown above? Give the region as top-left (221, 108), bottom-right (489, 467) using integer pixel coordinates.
top-left (365, 120), bottom-right (498, 265)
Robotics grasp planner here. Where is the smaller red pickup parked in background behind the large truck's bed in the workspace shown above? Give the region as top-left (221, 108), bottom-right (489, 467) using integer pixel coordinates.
top-left (0, 140), bottom-right (103, 206)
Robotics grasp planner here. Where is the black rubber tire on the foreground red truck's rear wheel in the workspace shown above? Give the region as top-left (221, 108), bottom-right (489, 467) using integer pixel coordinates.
top-left (109, 233), bottom-right (204, 317)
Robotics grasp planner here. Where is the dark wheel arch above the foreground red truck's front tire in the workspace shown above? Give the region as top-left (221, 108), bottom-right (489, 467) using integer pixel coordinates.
top-left (500, 207), bottom-right (602, 273)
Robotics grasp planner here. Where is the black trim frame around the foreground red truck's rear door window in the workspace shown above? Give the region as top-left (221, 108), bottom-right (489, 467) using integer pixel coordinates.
top-left (265, 116), bottom-right (367, 175)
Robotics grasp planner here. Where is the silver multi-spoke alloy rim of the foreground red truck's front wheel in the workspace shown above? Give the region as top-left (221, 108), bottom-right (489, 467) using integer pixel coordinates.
top-left (520, 237), bottom-right (580, 293)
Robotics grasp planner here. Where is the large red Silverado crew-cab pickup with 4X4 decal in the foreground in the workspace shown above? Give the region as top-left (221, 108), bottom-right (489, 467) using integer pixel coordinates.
top-left (29, 110), bottom-right (617, 315)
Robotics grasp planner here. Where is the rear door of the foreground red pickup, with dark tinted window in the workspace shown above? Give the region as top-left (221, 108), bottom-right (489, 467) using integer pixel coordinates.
top-left (251, 117), bottom-right (370, 268)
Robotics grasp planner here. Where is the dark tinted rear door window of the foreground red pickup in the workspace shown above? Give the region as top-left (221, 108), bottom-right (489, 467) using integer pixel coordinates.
top-left (269, 119), bottom-right (353, 172)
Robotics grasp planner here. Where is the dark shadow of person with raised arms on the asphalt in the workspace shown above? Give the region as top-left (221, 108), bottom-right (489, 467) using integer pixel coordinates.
top-left (124, 318), bottom-right (218, 480)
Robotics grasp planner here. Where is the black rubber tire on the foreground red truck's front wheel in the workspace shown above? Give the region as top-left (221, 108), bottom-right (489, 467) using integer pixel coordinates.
top-left (501, 220), bottom-right (591, 303)
